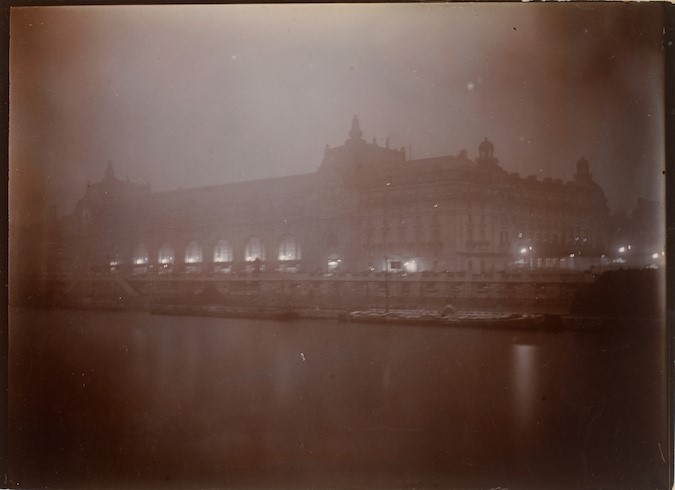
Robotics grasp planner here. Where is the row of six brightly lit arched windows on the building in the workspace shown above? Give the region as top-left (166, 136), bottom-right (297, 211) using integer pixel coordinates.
top-left (133, 235), bottom-right (302, 265)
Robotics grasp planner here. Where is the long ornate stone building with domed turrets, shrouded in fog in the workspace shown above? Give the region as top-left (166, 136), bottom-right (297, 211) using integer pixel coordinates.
top-left (58, 116), bottom-right (609, 274)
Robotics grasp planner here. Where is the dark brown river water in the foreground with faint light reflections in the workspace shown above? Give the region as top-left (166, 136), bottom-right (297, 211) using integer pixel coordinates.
top-left (8, 310), bottom-right (669, 489)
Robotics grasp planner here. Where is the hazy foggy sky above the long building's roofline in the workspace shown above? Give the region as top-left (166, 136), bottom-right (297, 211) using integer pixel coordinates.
top-left (9, 4), bottom-right (665, 225)
